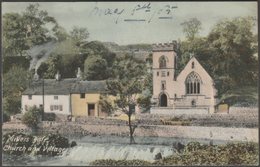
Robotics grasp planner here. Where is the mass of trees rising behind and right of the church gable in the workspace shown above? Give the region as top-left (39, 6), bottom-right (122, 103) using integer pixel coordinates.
top-left (178, 17), bottom-right (258, 97)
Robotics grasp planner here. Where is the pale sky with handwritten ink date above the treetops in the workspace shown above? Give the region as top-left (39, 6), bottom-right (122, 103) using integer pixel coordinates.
top-left (2, 1), bottom-right (258, 45)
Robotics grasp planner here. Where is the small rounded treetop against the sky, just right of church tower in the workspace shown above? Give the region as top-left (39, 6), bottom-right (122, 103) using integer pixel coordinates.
top-left (181, 18), bottom-right (202, 41)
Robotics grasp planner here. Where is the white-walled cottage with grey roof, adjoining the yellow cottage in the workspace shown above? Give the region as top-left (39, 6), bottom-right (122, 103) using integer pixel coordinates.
top-left (22, 74), bottom-right (77, 115)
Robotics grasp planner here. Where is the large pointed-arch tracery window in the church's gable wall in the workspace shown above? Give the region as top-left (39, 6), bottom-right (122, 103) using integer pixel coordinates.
top-left (185, 72), bottom-right (201, 94)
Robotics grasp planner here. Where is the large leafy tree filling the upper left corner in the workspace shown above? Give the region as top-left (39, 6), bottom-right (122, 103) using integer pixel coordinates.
top-left (3, 4), bottom-right (57, 56)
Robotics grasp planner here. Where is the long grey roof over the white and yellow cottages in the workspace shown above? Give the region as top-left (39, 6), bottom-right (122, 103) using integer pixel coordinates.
top-left (23, 78), bottom-right (106, 95)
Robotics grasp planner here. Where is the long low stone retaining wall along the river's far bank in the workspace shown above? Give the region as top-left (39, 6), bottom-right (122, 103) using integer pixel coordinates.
top-left (3, 122), bottom-right (258, 142)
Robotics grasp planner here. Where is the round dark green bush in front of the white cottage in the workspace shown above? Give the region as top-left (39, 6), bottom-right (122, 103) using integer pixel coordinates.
top-left (22, 106), bottom-right (43, 128)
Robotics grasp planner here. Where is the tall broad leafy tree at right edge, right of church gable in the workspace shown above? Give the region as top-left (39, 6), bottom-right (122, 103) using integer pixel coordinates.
top-left (208, 17), bottom-right (258, 86)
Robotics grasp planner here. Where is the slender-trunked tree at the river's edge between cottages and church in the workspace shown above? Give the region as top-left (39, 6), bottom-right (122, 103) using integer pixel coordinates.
top-left (107, 55), bottom-right (145, 144)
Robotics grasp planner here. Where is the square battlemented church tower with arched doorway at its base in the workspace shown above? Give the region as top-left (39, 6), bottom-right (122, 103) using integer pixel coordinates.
top-left (153, 41), bottom-right (177, 107)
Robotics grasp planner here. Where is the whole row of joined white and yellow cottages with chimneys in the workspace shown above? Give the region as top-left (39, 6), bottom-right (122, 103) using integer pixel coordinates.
top-left (22, 69), bottom-right (107, 117)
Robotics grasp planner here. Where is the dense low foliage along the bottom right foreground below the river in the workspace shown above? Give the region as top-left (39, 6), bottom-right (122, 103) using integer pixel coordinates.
top-left (91, 142), bottom-right (259, 166)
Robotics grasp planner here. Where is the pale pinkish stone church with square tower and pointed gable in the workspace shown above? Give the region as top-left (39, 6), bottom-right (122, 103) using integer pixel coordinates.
top-left (151, 41), bottom-right (217, 114)
